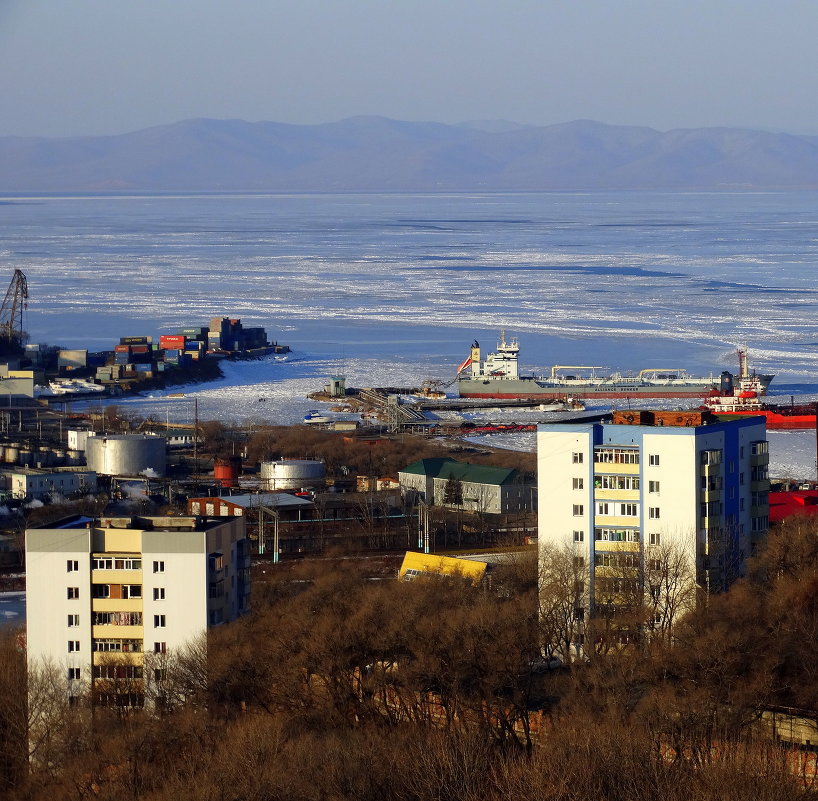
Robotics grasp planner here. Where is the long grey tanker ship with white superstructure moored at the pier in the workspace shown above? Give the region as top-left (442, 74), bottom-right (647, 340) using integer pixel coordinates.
top-left (455, 331), bottom-right (773, 400)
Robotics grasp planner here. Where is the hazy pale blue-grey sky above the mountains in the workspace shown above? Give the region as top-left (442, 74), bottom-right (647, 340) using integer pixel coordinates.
top-left (0, 0), bottom-right (818, 136)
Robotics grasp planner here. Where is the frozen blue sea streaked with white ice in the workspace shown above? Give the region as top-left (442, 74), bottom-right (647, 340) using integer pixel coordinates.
top-left (0, 192), bottom-right (818, 477)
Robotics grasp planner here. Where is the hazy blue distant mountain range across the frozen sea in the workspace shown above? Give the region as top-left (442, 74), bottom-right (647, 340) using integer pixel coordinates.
top-left (0, 117), bottom-right (818, 192)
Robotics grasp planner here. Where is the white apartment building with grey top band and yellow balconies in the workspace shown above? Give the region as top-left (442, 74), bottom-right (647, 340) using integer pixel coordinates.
top-left (26, 515), bottom-right (250, 706)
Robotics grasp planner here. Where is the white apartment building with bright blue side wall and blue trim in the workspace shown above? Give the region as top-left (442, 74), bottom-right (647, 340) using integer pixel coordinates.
top-left (537, 412), bottom-right (769, 618)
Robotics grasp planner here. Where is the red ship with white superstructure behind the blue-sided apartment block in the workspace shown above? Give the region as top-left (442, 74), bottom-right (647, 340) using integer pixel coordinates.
top-left (702, 351), bottom-right (818, 430)
